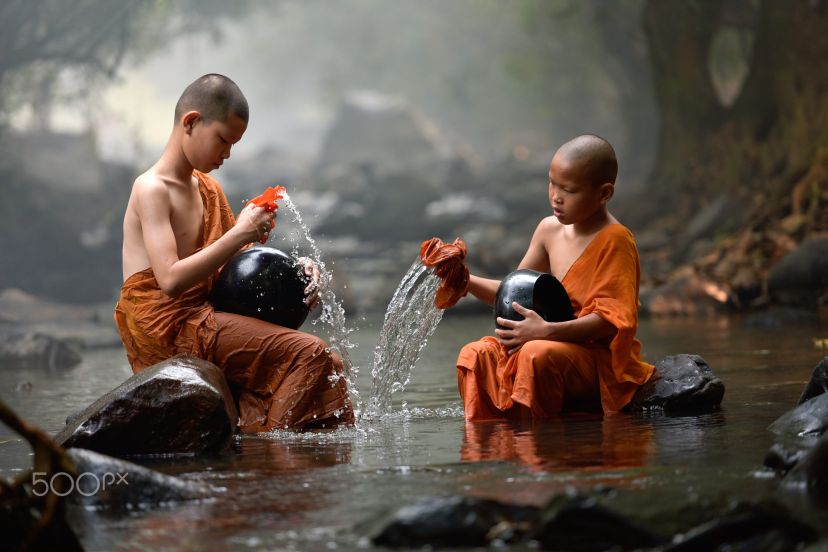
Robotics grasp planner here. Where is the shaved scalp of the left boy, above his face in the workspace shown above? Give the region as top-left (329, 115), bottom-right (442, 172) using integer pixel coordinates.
top-left (175, 73), bottom-right (250, 124)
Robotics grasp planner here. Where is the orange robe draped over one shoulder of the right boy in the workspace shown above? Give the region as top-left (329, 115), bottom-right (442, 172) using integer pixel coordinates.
top-left (457, 224), bottom-right (654, 420)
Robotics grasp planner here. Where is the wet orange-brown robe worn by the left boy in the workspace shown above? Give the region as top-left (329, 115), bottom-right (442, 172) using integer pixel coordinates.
top-left (115, 171), bottom-right (353, 433)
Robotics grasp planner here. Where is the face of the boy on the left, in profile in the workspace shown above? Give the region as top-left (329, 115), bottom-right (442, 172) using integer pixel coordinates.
top-left (182, 115), bottom-right (247, 173)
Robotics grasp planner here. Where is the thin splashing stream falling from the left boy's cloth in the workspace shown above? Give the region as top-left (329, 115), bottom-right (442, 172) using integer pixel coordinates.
top-left (271, 192), bottom-right (362, 419)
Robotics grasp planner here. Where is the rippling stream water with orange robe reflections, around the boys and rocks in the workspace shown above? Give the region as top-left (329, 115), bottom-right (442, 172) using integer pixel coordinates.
top-left (0, 312), bottom-right (828, 551)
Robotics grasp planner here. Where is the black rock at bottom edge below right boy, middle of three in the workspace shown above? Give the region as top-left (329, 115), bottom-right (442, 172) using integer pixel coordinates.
top-left (526, 495), bottom-right (665, 552)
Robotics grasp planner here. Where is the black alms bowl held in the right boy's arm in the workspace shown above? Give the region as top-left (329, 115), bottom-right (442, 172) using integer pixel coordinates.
top-left (494, 268), bottom-right (575, 328)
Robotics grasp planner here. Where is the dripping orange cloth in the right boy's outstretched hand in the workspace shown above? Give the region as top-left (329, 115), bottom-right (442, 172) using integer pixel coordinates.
top-left (420, 238), bottom-right (469, 309)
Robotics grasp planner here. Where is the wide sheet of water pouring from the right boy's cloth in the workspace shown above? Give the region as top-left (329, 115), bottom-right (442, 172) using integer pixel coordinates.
top-left (365, 259), bottom-right (443, 417)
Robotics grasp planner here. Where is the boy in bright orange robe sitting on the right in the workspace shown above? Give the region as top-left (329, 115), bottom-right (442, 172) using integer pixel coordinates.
top-left (457, 135), bottom-right (654, 420)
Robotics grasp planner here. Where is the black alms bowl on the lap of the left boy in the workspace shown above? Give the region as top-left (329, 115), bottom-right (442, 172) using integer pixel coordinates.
top-left (211, 247), bottom-right (309, 330)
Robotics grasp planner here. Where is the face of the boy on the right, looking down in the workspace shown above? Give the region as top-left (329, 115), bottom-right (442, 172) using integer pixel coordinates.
top-left (549, 155), bottom-right (612, 224)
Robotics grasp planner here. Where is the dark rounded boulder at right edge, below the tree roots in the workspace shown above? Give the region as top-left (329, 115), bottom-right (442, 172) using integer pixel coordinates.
top-left (768, 236), bottom-right (828, 308)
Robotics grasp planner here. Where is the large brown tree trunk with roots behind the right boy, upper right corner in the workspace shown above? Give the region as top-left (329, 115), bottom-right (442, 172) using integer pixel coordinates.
top-left (624, 0), bottom-right (828, 304)
